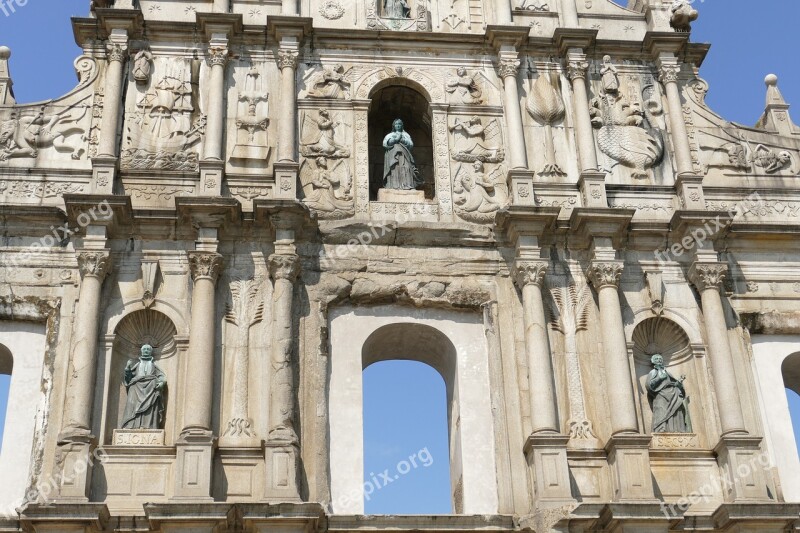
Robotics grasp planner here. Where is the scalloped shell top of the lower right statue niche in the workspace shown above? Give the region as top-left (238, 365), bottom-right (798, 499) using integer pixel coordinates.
top-left (632, 317), bottom-right (692, 366)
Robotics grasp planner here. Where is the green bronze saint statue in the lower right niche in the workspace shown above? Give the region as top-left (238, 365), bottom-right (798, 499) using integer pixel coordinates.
top-left (645, 354), bottom-right (692, 433)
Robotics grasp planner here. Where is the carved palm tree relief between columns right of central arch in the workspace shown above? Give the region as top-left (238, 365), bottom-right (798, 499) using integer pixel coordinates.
top-left (550, 284), bottom-right (597, 441)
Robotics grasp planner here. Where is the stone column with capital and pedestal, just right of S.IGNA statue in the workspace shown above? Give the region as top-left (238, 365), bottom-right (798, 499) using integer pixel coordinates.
top-left (174, 251), bottom-right (223, 500)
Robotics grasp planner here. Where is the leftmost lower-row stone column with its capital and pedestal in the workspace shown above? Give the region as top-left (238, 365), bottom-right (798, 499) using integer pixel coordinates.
top-left (58, 250), bottom-right (111, 501)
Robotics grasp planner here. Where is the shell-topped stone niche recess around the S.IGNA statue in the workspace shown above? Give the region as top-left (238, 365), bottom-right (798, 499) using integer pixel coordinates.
top-left (104, 309), bottom-right (180, 444)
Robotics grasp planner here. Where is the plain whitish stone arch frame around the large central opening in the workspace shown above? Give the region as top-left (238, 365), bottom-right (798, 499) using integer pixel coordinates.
top-left (328, 306), bottom-right (498, 514)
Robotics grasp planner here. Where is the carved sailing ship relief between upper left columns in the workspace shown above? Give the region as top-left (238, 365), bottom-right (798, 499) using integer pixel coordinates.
top-left (121, 61), bottom-right (206, 171)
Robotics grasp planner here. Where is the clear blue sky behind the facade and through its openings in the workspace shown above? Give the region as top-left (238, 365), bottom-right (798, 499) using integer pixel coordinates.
top-left (0, 0), bottom-right (800, 513)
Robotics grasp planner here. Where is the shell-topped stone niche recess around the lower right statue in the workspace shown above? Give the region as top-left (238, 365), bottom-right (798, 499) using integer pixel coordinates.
top-left (631, 317), bottom-right (710, 438)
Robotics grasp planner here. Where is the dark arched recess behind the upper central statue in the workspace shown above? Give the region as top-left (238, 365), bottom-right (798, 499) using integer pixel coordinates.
top-left (368, 85), bottom-right (436, 200)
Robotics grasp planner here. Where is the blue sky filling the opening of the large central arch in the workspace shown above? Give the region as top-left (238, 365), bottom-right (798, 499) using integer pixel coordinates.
top-left (363, 360), bottom-right (453, 514)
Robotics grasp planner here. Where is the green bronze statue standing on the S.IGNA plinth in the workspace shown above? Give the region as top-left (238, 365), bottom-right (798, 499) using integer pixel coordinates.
top-left (122, 344), bottom-right (167, 429)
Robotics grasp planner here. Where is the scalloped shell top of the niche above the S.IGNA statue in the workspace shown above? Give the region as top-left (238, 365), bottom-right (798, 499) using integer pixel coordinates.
top-left (114, 309), bottom-right (177, 359)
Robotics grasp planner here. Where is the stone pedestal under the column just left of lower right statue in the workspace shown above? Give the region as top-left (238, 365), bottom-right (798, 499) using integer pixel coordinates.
top-left (606, 434), bottom-right (658, 503)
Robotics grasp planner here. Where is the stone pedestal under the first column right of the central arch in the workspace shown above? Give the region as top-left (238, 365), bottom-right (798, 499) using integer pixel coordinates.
top-left (524, 433), bottom-right (575, 504)
